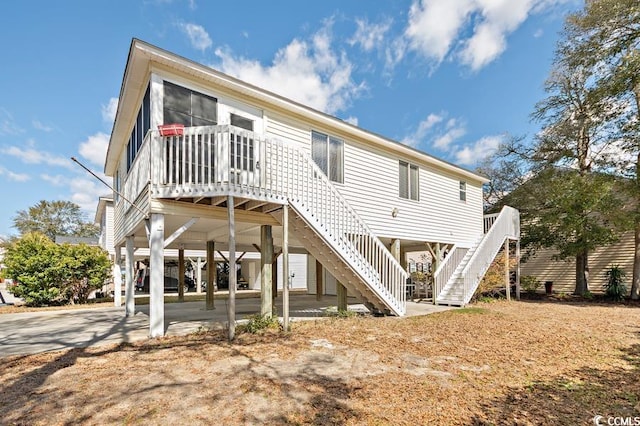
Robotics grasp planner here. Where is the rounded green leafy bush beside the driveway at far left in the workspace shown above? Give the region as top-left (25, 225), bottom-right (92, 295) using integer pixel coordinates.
top-left (3, 232), bottom-right (111, 306)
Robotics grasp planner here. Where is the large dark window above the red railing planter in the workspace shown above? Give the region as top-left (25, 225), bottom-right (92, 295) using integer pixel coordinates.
top-left (163, 81), bottom-right (218, 127)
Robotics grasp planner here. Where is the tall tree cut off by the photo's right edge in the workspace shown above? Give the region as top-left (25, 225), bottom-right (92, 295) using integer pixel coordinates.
top-left (566, 0), bottom-right (640, 299)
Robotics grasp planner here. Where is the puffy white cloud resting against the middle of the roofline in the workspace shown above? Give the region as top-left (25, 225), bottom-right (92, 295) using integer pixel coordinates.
top-left (215, 22), bottom-right (365, 114)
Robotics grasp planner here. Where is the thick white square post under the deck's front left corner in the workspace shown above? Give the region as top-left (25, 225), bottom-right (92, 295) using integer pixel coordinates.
top-left (149, 213), bottom-right (164, 337)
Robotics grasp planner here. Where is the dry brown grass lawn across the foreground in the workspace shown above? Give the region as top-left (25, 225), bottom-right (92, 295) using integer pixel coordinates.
top-left (0, 301), bottom-right (640, 425)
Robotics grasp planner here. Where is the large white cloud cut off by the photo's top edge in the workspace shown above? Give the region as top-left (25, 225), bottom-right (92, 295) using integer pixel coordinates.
top-left (404, 0), bottom-right (570, 71)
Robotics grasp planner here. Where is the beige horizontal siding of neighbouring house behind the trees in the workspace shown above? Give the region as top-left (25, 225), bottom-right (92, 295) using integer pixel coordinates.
top-left (521, 233), bottom-right (634, 293)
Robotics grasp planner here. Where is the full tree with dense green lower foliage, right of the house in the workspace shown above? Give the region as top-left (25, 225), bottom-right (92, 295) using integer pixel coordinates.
top-left (488, 44), bottom-right (625, 294)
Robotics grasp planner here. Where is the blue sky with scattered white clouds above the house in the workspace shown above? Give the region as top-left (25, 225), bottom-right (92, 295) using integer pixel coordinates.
top-left (0, 0), bottom-right (582, 236)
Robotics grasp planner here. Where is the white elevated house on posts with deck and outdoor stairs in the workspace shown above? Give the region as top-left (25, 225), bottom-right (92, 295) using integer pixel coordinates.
top-left (105, 40), bottom-right (519, 337)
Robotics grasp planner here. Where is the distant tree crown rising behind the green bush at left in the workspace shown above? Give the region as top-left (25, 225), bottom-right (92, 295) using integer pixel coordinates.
top-left (13, 200), bottom-right (100, 241)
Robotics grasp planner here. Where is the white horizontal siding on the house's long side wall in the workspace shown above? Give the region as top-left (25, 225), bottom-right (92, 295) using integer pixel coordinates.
top-left (265, 112), bottom-right (483, 246)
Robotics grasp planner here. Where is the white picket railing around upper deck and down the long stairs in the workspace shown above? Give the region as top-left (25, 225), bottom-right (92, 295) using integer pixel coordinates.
top-left (138, 125), bottom-right (407, 315)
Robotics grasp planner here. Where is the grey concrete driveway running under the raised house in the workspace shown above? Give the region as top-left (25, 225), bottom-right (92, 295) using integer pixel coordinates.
top-left (0, 295), bottom-right (451, 357)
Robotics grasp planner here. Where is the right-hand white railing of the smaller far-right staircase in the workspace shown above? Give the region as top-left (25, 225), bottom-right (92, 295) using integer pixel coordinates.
top-left (461, 206), bottom-right (520, 305)
